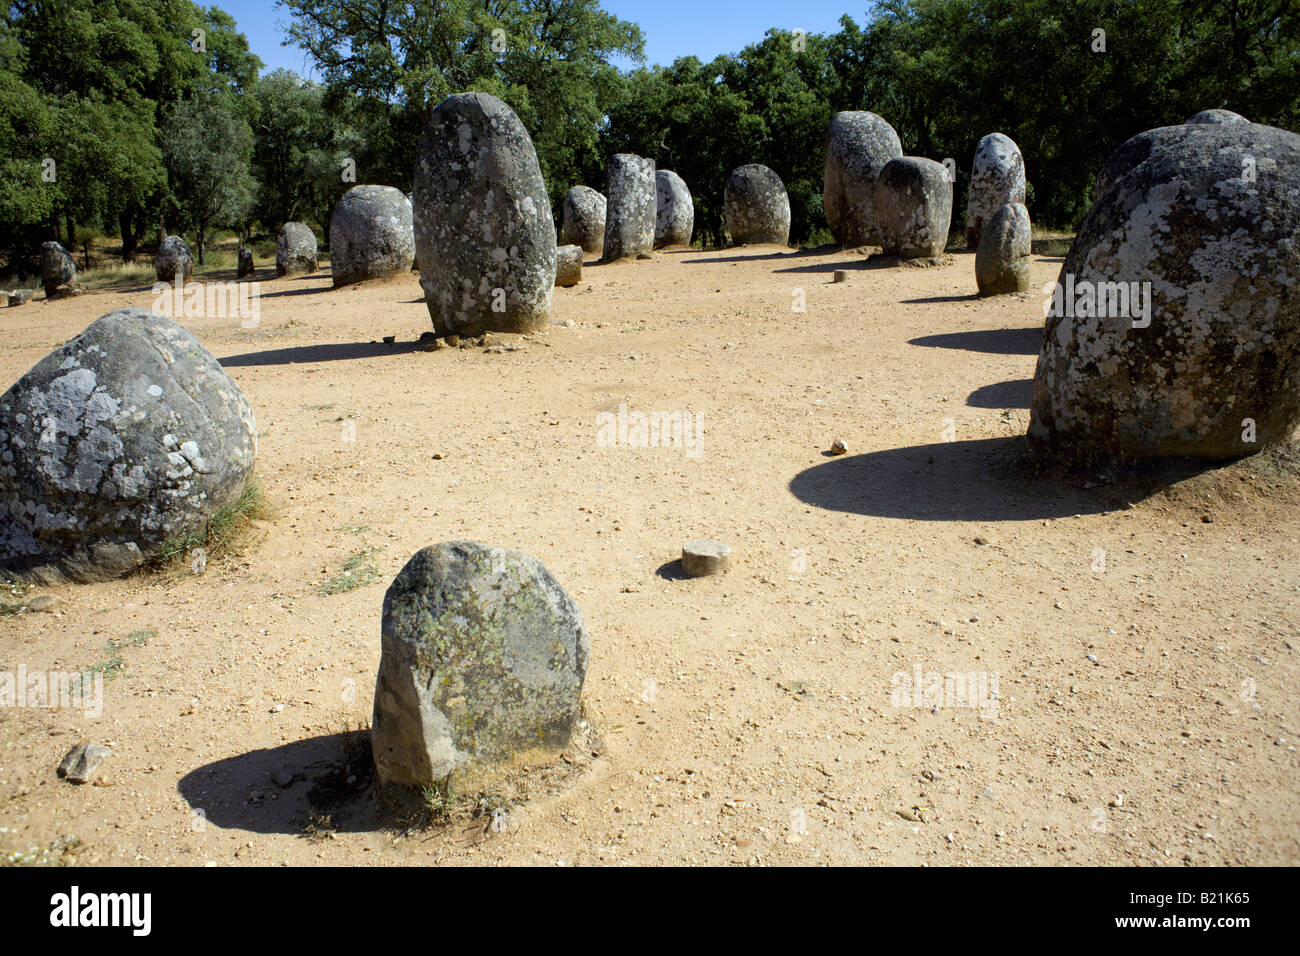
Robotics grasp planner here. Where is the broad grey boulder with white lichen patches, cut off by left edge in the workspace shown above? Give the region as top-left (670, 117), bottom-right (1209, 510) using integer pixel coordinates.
top-left (0, 308), bottom-right (257, 580)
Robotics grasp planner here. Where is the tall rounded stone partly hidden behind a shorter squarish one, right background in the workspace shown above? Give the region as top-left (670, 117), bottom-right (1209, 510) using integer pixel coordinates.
top-left (822, 109), bottom-right (902, 246)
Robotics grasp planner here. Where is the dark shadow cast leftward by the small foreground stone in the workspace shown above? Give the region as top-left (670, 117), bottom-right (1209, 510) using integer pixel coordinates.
top-left (177, 730), bottom-right (382, 834)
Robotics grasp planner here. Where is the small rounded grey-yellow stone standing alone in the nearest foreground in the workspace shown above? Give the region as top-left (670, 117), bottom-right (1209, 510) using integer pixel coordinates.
top-left (371, 541), bottom-right (590, 787)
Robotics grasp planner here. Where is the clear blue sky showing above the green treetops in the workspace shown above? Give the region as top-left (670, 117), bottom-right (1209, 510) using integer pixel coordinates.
top-left (223, 0), bottom-right (870, 73)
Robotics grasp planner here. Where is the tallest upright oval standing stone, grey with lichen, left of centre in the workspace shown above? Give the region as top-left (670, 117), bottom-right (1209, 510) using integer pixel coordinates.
top-left (415, 92), bottom-right (555, 336)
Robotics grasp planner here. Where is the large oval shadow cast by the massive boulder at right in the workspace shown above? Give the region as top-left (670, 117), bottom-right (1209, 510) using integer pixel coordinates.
top-left (790, 436), bottom-right (1125, 522)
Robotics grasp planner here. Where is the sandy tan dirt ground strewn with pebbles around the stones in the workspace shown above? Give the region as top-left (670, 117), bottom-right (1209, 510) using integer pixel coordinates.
top-left (0, 247), bottom-right (1300, 865)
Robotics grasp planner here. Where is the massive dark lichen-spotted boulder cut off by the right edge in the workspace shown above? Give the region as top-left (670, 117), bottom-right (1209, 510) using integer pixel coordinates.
top-left (1028, 122), bottom-right (1300, 462)
